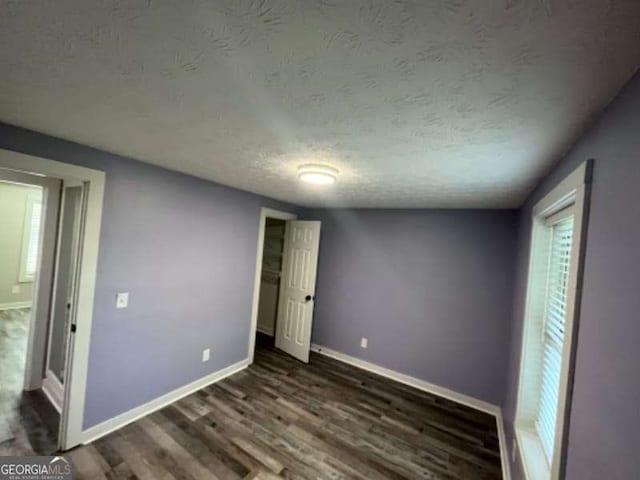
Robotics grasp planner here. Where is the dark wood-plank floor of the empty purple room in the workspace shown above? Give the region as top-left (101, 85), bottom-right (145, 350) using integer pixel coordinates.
top-left (66, 338), bottom-right (501, 480)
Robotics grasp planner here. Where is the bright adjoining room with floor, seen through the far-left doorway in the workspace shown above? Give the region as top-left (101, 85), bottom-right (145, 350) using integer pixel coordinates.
top-left (0, 179), bottom-right (60, 456)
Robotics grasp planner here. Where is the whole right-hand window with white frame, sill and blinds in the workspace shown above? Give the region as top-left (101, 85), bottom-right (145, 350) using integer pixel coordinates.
top-left (516, 163), bottom-right (590, 480)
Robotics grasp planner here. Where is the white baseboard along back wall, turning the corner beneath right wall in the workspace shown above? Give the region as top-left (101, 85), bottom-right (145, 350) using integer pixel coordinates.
top-left (311, 344), bottom-right (511, 480)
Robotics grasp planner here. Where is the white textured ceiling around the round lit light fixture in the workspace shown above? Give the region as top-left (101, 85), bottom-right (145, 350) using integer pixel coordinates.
top-left (0, 0), bottom-right (640, 208)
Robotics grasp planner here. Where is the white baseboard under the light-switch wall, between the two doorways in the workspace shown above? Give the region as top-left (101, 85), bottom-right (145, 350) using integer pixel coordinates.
top-left (82, 359), bottom-right (249, 445)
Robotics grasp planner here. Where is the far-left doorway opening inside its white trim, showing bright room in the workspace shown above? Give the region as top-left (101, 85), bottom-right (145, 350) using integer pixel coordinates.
top-left (0, 169), bottom-right (84, 455)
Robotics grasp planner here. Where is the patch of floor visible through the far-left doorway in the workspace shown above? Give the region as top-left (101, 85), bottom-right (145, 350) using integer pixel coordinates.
top-left (0, 309), bottom-right (59, 456)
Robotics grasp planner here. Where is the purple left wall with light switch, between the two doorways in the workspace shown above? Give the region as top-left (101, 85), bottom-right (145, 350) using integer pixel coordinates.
top-left (0, 124), bottom-right (291, 428)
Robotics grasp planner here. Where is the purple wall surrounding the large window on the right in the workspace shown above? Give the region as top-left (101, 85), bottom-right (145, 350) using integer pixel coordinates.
top-left (504, 69), bottom-right (640, 480)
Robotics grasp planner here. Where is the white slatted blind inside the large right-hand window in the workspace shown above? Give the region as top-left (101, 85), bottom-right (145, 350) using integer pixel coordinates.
top-left (535, 216), bottom-right (574, 463)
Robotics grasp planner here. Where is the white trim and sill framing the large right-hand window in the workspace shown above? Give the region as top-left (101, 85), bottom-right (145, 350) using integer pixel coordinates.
top-left (515, 160), bottom-right (593, 480)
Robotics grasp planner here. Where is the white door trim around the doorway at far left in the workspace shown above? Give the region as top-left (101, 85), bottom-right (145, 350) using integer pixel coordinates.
top-left (0, 149), bottom-right (105, 450)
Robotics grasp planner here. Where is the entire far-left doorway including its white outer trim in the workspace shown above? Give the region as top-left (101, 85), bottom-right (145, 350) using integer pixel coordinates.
top-left (0, 149), bottom-right (105, 456)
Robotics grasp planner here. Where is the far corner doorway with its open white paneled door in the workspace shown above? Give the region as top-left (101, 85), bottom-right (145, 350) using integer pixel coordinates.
top-left (249, 208), bottom-right (320, 362)
